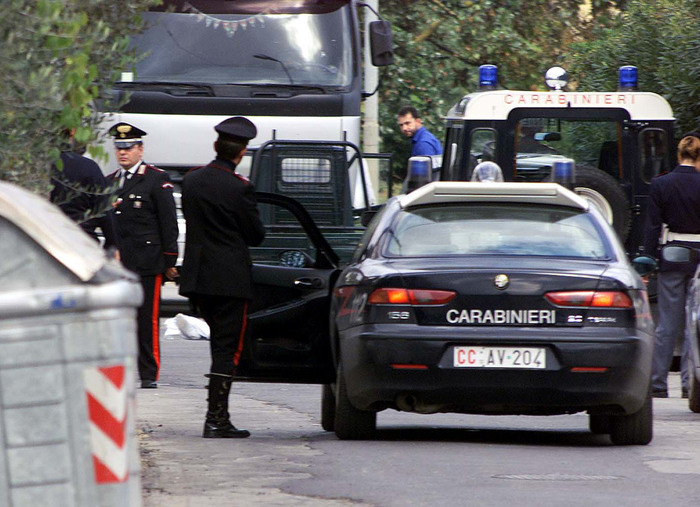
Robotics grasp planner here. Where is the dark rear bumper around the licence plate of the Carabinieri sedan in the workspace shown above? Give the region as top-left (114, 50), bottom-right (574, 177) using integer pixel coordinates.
top-left (340, 326), bottom-right (653, 415)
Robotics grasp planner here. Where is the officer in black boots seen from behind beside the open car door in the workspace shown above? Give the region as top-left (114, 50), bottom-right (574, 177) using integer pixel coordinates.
top-left (180, 116), bottom-right (265, 438)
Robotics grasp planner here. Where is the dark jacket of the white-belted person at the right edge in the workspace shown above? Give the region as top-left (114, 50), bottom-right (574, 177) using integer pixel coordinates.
top-left (644, 165), bottom-right (700, 274)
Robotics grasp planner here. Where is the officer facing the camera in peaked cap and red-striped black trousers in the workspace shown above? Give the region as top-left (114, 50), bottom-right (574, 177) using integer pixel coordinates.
top-left (109, 123), bottom-right (178, 388)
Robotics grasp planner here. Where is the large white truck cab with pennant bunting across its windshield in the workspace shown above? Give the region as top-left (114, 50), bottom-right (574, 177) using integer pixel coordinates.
top-left (103, 0), bottom-right (393, 205)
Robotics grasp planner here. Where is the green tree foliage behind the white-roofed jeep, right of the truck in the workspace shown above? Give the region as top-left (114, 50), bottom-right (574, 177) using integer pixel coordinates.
top-left (380, 0), bottom-right (700, 179)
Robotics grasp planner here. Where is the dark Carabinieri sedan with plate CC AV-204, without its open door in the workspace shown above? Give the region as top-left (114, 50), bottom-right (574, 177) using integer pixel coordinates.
top-left (323, 183), bottom-right (653, 444)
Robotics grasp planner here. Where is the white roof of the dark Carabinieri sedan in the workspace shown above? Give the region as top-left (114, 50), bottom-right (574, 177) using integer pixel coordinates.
top-left (399, 181), bottom-right (589, 211)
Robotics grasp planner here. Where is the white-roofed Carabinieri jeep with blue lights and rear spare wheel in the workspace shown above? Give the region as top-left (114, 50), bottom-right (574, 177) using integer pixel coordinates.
top-left (439, 65), bottom-right (675, 255)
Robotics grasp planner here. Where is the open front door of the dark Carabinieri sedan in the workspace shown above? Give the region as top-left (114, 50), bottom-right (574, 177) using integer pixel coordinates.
top-left (236, 192), bottom-right (340, 384)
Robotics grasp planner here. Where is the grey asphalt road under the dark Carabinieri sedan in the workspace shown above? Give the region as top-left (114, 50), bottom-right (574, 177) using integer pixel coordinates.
top-left (137, 339), bottom-right (700, 507)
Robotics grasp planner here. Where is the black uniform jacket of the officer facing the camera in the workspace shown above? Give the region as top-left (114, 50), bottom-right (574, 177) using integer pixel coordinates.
top-left (109, 162), bottom-right (178, 275)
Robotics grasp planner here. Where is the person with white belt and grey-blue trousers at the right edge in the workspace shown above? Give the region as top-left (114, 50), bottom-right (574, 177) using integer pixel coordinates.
top-left (644, 133), bottom-right (700, 398)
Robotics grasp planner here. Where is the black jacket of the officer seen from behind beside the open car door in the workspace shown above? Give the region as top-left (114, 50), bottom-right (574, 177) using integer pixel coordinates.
top-left (180, 158), bottom-right (265, 299)
